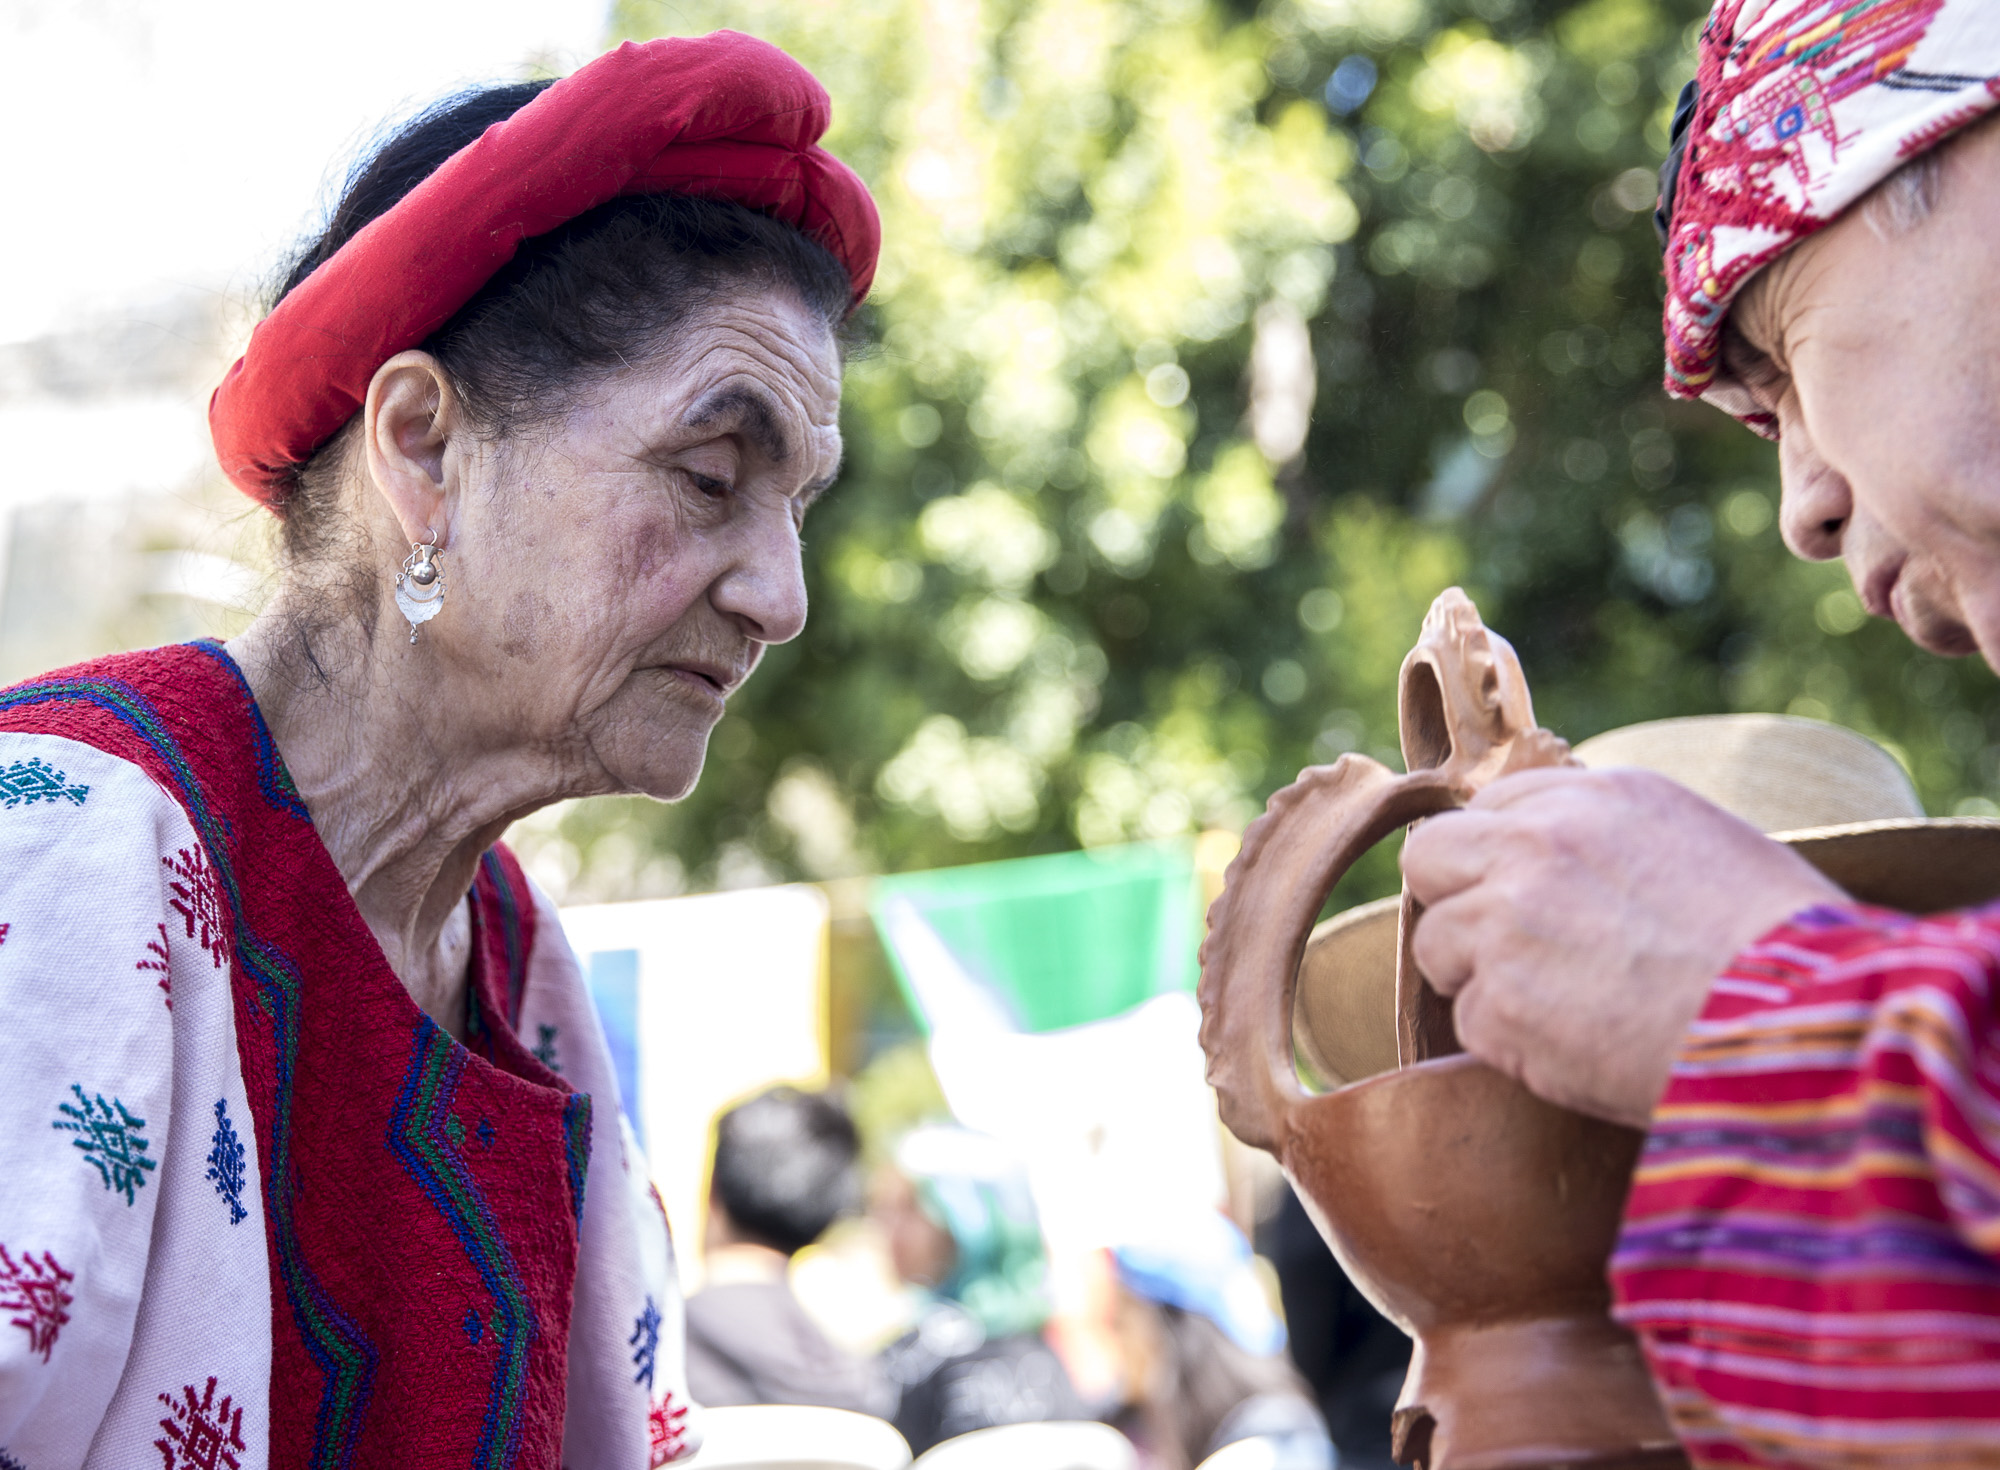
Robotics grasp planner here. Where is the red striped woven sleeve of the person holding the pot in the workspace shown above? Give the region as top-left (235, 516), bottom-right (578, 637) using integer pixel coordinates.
top-left (1612, 906), bottom-right (2000, 1470)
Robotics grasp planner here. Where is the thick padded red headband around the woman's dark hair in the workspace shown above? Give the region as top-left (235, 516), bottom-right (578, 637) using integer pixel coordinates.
top-left (208, 30), bottom-right (882, 504)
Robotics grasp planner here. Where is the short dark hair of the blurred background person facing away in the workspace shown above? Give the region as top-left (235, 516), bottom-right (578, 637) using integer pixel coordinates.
top-left (708, 1088), bottom-right (862, 1256)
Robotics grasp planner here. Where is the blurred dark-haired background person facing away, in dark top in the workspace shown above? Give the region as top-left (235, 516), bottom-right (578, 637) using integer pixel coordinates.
top-left (688, 1086), bottom-right (896, 1418)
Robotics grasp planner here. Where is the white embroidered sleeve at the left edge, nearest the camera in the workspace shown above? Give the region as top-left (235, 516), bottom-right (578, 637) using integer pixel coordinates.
top-left (0, 730), bottom-right (270, 1470)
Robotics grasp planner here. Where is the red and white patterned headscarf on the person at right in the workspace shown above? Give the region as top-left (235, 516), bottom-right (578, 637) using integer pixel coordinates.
top-left (1662, 0), bottom-right (2000, 436)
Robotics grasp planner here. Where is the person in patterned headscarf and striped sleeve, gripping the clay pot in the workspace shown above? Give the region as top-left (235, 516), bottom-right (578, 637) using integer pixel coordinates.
top-left (1404, 0), bottom-right (2000, 1470)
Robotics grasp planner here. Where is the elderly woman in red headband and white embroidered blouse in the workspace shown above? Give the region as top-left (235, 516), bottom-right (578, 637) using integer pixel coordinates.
top-left (0, 32), bottom-right (878, 1470)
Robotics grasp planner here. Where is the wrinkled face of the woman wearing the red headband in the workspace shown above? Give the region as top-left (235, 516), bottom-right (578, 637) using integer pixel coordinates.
top-left (434, 288), bottom-right (840, 800)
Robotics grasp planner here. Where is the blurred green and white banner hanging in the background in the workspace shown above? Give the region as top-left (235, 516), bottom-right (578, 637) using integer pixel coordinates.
top-left (872, 844), bottom-right (1226, 1256)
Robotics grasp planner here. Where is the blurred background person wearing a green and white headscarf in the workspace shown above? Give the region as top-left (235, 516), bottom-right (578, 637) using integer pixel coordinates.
top-left (872, 1126), bottom-right (1088, 1454)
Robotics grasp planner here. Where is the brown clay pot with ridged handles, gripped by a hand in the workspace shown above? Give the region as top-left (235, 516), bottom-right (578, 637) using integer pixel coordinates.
top-left (1200, 588), bottom-right (1686, 1470)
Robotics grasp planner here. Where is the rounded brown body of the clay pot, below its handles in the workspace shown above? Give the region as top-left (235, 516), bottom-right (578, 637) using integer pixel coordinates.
top-left (1284, 1056), bottom-right (1686, 1470)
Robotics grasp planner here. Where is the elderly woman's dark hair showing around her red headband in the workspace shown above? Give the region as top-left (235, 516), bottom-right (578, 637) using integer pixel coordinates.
top-left (272, 82), bottom-right (852, 562)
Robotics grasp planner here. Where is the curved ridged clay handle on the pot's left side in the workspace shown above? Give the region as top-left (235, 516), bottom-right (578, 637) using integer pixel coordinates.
top-left (1196, 756), bottom-right (1460, 1152)
